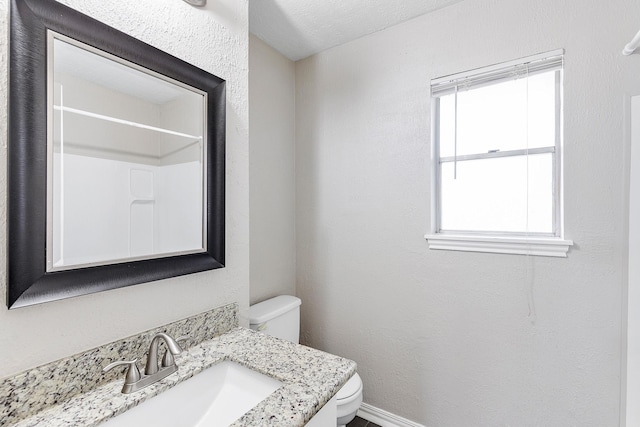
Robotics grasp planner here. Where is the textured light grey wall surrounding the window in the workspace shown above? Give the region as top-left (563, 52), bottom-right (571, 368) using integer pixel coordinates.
top-left (296, 0), bottom-right (640, 427)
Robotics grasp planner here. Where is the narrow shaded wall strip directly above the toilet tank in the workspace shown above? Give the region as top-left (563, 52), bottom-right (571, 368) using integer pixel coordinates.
top-left (249, 35), bottom-right (296, 304)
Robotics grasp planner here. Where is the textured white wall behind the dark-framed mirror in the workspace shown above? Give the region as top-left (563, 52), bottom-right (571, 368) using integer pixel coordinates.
top-left (0, 0), bottom-right (249, 377)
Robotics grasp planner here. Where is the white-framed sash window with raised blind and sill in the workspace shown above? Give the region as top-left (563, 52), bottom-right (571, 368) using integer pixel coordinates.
top-left (426, 51), bottom-right (572, 256)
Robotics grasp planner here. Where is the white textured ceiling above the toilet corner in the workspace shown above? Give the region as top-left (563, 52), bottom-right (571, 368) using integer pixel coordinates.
top-left (249, 0), bottom-right (462, 61)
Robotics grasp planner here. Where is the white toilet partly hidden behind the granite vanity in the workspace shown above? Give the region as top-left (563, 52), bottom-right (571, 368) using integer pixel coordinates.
top-left (249, 295), bottom-right (362, 427)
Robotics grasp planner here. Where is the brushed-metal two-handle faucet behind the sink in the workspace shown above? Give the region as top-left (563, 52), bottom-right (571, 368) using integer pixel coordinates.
top-left (102, 332), bottom-right (185, 394)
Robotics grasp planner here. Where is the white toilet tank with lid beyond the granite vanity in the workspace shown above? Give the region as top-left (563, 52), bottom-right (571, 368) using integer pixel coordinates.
top-left (249, 295), bottom-right (302, 344)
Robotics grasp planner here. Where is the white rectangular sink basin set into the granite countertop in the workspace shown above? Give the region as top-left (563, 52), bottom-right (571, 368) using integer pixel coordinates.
top-left (102, 361), bottom-right (282, 427)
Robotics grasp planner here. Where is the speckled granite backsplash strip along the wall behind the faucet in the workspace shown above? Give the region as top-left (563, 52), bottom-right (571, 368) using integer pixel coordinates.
top-left (0, 304), bottom-right (238, 426)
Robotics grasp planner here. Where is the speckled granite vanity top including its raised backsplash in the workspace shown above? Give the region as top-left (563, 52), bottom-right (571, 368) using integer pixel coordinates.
top-left (0, 304), bottom-right (356, 427)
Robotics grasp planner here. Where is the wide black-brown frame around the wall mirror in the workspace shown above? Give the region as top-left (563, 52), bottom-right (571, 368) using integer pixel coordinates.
top-left (7, 0), bottom-right (226, 308)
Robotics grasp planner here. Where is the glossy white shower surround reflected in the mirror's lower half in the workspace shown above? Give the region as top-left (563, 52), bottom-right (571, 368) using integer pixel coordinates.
top-left (54, 154), bottom-right (202, 265)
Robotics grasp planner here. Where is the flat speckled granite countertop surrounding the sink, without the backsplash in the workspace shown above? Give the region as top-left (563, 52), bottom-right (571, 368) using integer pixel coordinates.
top-left (10, 327), bottom-right (356, 427)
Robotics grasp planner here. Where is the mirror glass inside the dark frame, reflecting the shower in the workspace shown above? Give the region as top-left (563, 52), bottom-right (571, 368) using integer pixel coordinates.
top-left (47, 31), bottom-right (207, 271)
